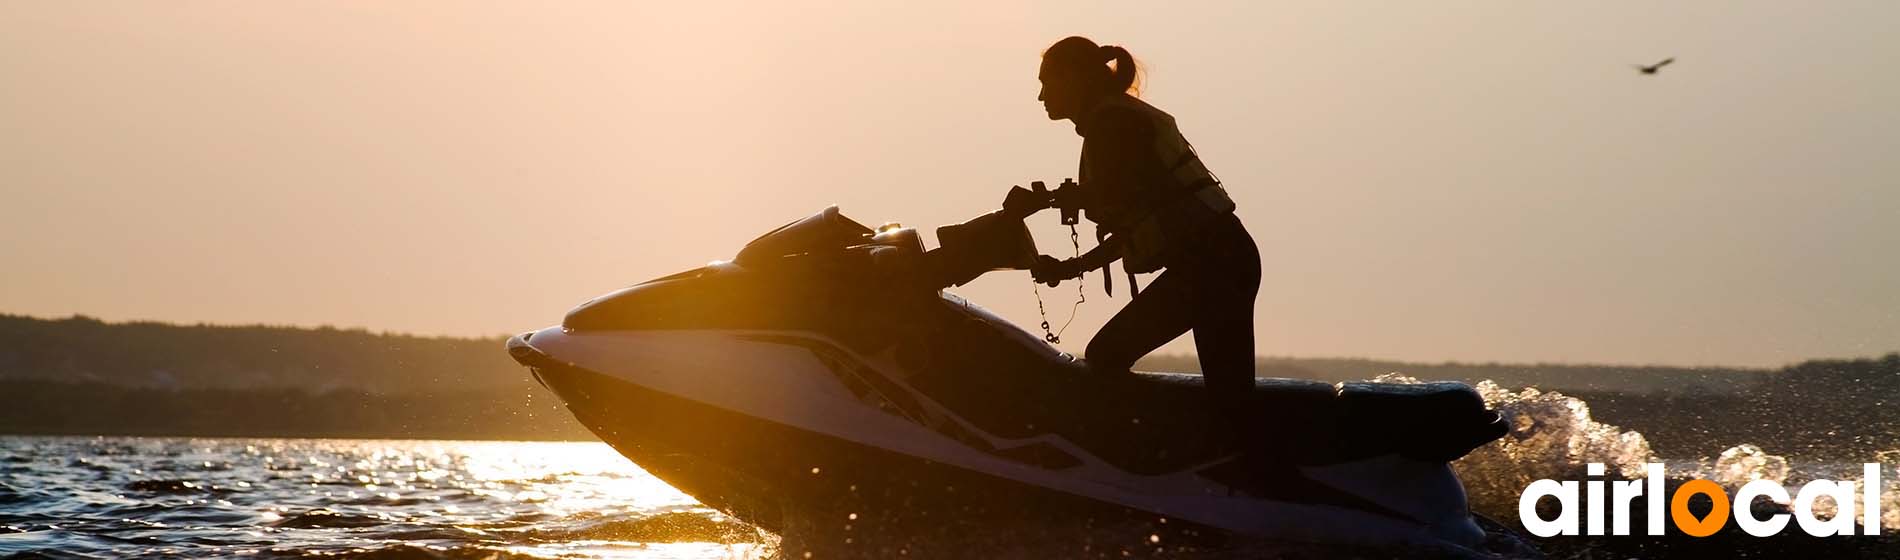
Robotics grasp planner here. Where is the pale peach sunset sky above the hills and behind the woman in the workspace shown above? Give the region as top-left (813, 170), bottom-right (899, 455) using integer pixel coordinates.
top-left (0, 0), bottom-right (1900, 366)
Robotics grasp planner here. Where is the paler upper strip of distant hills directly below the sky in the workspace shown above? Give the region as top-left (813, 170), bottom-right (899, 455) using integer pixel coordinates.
top-left (0, 313), bottom-right (1777, 393)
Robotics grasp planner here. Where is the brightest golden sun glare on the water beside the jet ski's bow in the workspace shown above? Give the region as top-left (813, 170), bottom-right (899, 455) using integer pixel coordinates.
top-left (290, 440), bottom-right (775, 558)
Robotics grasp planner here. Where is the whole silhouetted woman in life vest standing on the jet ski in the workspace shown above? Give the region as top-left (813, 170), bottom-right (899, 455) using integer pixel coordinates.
top-left (1005, 36), bottom-right (1260, 427)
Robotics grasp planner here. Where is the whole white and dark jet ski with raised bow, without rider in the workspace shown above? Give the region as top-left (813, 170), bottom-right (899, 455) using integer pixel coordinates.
top-left (507, 207), bottom-right (1507, 549)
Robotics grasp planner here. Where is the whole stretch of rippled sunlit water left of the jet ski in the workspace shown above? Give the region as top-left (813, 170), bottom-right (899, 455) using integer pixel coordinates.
top-left (0, 437), bottom-right (775, 558)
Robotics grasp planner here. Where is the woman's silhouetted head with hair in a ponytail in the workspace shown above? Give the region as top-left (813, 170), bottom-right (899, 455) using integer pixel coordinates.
top-left (1036, 36), bottom-right (1140, 120)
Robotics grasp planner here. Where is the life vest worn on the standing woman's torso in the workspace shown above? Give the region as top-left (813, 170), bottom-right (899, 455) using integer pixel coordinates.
top-left (1077, 95), bottom-right (1233, 275)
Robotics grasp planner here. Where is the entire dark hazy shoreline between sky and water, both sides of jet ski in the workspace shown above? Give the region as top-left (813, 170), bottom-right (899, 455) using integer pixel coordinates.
top-left (0, 315), bottom-right (1900, 459)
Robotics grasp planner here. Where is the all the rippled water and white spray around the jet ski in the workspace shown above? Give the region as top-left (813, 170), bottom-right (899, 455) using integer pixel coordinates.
top-left (0, 383), bottom-right (1900, 560)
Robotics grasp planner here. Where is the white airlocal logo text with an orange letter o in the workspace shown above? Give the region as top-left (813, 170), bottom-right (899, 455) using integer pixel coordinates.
top-left (1518, 463), bottom-right (1881, 537)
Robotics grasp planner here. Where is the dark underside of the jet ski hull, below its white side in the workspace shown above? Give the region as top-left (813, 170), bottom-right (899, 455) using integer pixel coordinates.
top-left (536, 353), bottom-right (1226, 552)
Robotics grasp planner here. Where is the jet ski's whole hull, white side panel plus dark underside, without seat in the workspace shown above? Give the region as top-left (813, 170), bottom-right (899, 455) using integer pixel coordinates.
top-left (509, 327), bottom-right (1484, 547)
